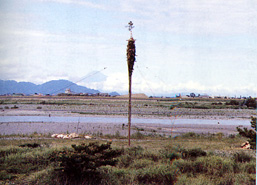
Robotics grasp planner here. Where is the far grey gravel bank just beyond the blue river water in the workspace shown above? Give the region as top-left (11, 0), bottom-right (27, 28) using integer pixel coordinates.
top-left (0, 102), bottom-right (254, 120)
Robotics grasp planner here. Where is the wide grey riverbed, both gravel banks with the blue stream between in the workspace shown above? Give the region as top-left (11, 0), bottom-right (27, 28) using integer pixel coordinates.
top-left (0, 100), bottom-right (253, 135)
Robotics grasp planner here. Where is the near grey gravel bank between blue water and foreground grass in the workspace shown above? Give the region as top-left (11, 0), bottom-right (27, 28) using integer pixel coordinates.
top-left (0, 119), bottom-right (250, 136)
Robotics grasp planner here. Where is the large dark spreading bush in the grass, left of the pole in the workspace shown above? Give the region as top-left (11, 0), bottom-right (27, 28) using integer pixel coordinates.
top-left (50, 143), bottom-right (121, 184)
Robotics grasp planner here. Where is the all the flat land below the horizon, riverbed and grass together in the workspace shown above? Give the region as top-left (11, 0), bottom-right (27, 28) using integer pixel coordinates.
top-left (0, 97), bottom-right (256, 184)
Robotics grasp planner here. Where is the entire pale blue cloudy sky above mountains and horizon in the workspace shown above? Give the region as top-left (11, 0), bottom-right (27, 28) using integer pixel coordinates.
top-left (0, 0), bottom-right (257, 97)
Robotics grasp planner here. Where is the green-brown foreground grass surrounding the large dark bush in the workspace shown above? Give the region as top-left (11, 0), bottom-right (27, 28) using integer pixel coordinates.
top-left (0, 133), bottom-right (256, 184)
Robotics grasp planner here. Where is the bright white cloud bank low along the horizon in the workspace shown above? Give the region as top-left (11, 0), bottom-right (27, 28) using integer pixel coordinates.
top-left (83, 73), bottom-right (257, 96)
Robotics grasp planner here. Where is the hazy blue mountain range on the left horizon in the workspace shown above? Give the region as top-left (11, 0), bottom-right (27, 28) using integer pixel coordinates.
top-left (0, 80), bottom-right (100, 95)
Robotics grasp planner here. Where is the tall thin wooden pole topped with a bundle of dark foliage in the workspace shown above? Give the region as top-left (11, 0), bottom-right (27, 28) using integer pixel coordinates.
top-left (126, 21), bottom-right (136, 146)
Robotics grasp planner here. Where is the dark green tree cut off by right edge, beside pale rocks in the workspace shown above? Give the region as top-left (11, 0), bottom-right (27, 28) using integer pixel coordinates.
top-left (236, 116), bottom-right (256, 149)
